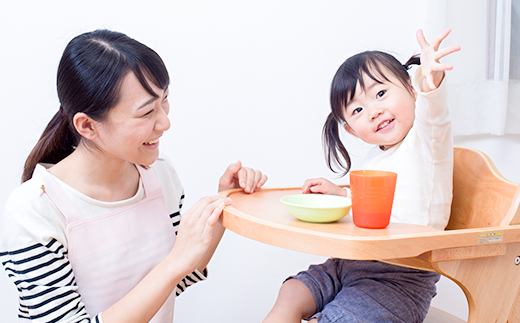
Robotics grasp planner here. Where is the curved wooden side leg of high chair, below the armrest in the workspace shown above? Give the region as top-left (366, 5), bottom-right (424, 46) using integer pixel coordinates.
top-left (432, 243), bottom-right (520, 323)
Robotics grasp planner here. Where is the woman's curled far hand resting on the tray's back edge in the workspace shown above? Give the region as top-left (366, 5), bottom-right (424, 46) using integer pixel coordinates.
top-left (218, 161), bottom-right (267, 193)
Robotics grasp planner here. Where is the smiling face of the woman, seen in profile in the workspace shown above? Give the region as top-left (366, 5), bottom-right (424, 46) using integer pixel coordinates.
top-left (94, 73), bottom-right (170, 165)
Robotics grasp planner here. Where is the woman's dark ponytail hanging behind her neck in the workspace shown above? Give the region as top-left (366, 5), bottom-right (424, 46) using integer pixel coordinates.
top-left (22, 107), bottom-right (77, 183)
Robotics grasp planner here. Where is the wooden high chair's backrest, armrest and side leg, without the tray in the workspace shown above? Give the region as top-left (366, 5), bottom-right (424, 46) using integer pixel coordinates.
top-left (410, 147), bottom-right (520, 323)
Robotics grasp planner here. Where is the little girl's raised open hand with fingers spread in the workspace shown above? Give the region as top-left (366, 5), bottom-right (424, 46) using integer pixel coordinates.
top-left (416, 28), bottom-right (460, 92)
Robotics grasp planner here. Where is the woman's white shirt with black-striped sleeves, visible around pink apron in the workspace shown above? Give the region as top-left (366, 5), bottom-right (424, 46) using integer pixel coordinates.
top-left (0, 156), bottom-right (207, 323)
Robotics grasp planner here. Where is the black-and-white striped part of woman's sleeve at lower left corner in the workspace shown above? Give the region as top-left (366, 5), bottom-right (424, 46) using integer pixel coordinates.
top-left (0, 239), bottom-right (102, 323)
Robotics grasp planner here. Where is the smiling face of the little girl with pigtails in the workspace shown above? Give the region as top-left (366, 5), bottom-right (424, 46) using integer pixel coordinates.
top-left (343, 68), bottom-right (416, 149)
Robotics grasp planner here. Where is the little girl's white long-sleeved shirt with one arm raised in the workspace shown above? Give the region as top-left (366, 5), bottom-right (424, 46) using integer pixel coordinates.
top-left (356, 68), bottom-right (453, 230)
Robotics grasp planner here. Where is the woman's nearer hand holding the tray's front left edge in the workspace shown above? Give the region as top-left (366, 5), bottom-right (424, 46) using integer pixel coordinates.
top-left (170, 195), bottom-right (231, 274)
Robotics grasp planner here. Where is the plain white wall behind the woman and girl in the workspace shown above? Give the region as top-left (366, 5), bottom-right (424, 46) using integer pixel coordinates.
top-left (0, 0), bottom-right (520, 323)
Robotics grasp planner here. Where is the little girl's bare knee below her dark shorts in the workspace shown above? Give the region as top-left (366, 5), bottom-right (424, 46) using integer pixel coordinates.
top-left (263, 279), bottom-right (318, 323)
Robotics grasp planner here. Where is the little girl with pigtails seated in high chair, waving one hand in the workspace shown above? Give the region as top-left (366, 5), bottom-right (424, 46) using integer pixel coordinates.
top-left (264, 30), bottom-right (460, 323)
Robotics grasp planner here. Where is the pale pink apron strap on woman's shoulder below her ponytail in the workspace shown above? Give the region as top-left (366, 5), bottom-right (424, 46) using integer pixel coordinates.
top-left (42, 170), bottom-right (81, 226)
